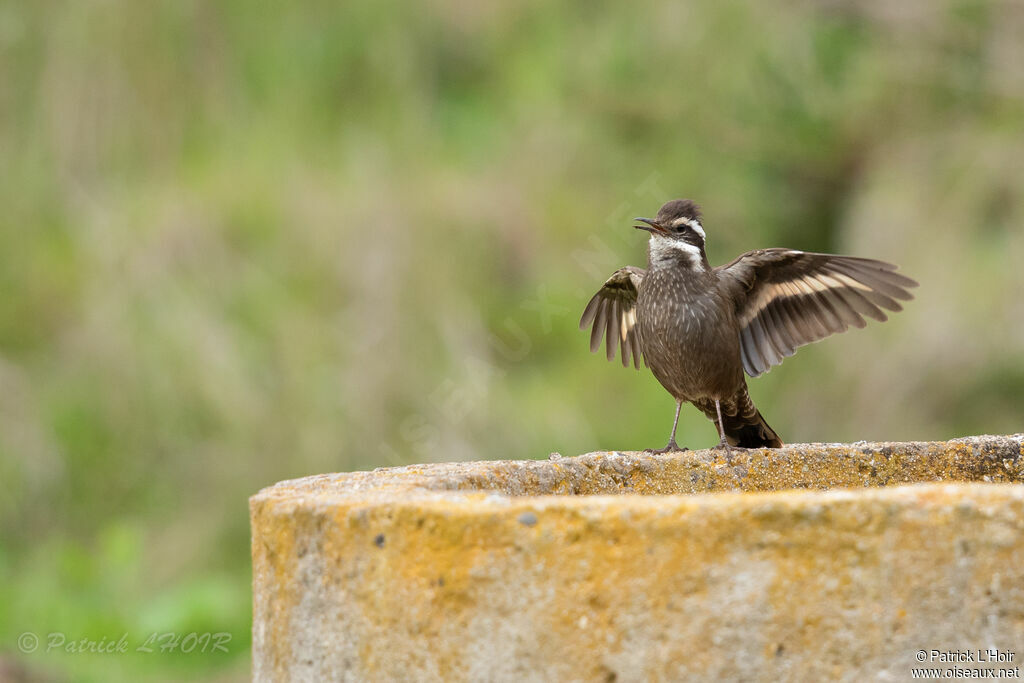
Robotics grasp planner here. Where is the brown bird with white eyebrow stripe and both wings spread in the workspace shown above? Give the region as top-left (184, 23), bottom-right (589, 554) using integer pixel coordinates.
top-left (580, 200), bottom-right (918, 454)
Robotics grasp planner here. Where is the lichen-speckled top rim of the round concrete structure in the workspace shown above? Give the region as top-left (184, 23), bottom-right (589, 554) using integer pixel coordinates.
top-left (250, 433), bottom-right (1024, 509)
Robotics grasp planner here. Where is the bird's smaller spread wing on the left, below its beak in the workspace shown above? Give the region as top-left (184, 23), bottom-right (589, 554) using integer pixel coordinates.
top-left (580, 265), bottom-right (646, 369)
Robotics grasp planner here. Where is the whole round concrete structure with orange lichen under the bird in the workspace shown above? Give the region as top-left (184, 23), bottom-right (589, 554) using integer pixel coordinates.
top-left (250, 434), bottom-right (1024, 681)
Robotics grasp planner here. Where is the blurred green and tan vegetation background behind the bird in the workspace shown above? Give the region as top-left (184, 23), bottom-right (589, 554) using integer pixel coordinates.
top-left (0, 0), bottom-right (1024, 681)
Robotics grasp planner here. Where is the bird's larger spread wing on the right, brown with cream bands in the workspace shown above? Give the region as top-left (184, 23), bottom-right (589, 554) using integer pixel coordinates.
top-left (715, 249), bottom-right (918, 377)
